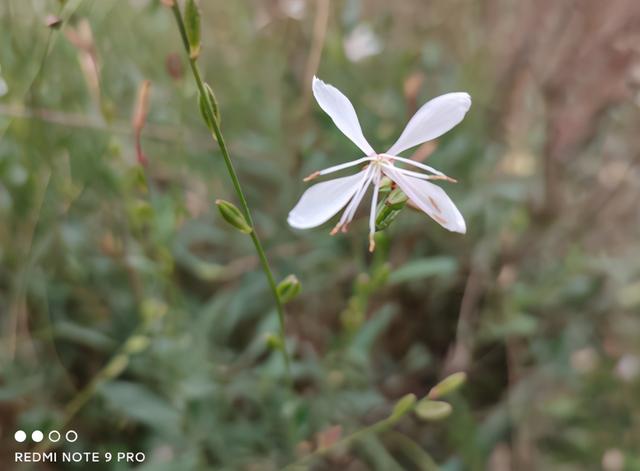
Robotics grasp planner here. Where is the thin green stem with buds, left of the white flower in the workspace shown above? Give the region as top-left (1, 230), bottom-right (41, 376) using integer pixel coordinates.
top-left (171, 1), bottom-right (291, 377)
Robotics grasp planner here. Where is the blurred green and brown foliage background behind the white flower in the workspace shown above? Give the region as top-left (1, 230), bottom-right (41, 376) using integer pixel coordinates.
top-left (0, 0), bottom-right (640, 471)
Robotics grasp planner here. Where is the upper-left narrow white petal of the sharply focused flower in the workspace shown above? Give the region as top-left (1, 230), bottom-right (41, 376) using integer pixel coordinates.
top-left (312, 77), bottom-right (375, 155)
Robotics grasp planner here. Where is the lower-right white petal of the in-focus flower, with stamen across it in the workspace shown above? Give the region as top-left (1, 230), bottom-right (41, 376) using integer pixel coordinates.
top-left (385, 168), bottom-right (467, 234)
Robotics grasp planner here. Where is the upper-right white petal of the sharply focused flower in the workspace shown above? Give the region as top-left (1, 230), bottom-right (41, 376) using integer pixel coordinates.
top-left (387, 92), bottom-right (471, 155)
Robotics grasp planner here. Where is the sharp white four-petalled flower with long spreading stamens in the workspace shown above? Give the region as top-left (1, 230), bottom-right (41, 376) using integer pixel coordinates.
top-left (287, 77), bottom-right (471, 251)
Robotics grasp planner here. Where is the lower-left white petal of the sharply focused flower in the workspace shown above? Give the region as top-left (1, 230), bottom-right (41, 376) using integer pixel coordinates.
top-left (287, 170), bottom-right (367, 229)
